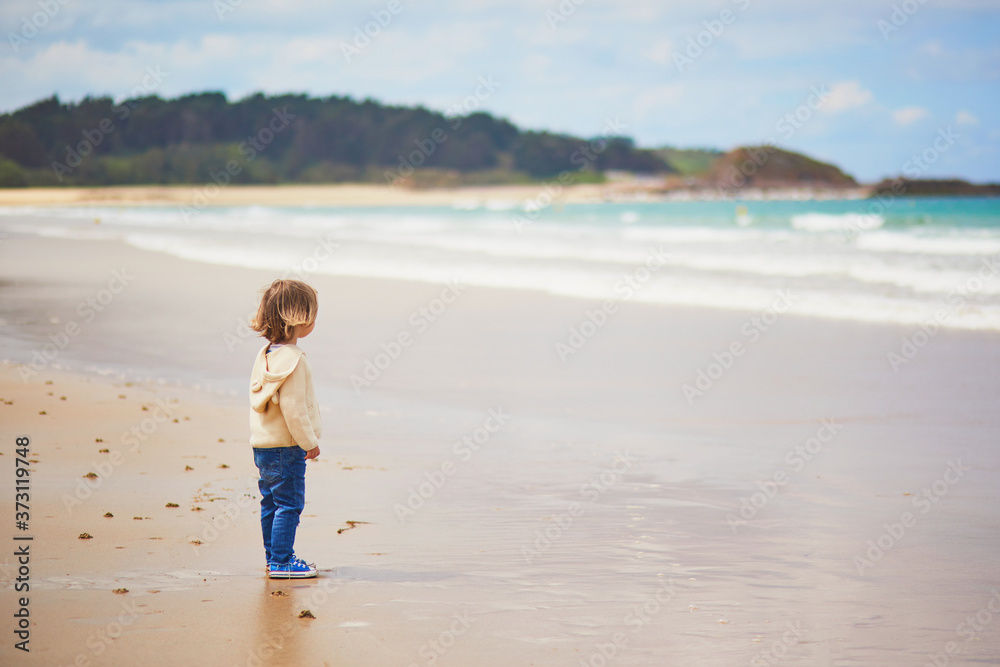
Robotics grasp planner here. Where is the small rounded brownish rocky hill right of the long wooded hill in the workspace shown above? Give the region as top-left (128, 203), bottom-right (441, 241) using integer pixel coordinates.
top-left (705, 146), bottom-right (858, 189)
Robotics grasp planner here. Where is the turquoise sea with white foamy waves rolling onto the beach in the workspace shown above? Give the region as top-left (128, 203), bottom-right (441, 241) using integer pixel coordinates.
top-left (0, 198), bottom-right (1000, 330)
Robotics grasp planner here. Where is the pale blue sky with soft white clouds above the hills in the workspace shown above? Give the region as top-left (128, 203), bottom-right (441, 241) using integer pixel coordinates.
top-left (0, 0), bottom-right (1000, 182)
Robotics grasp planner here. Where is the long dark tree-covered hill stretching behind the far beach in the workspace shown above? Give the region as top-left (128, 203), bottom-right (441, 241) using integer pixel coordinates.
top-left (0, 92), bottom-right (673, 186)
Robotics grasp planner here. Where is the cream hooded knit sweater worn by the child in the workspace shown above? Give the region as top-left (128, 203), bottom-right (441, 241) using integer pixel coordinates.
top-left (250, 345), bottom-right (322, 451)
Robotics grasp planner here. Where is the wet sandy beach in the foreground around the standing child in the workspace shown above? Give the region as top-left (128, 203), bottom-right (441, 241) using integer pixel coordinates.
top-left (0, 222), bottom-right (1000, 667)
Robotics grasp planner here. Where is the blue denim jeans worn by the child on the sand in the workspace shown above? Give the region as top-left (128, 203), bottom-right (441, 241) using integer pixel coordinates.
top-left (253, 447), bottom-right (306, 565)
